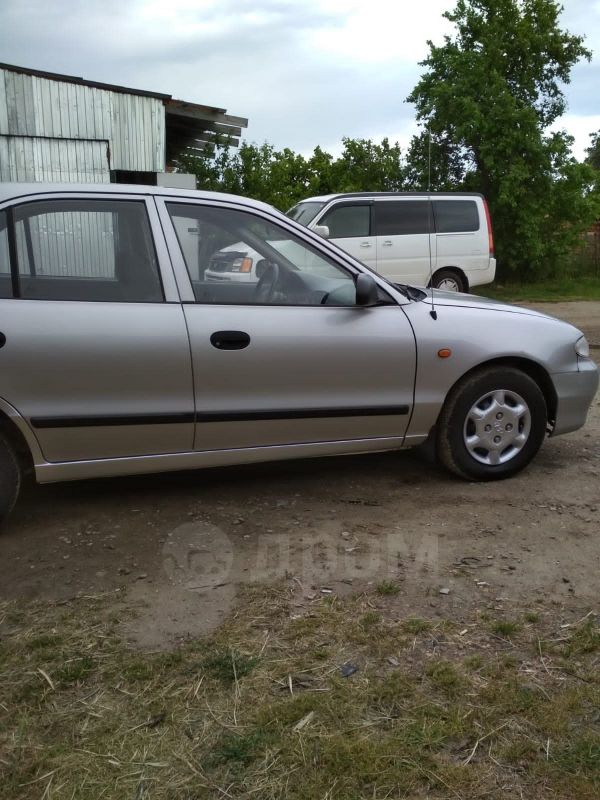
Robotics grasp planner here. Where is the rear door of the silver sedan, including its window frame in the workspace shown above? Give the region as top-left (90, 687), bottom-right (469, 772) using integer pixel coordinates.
top-left (0, 193), bottom-right (194, 462)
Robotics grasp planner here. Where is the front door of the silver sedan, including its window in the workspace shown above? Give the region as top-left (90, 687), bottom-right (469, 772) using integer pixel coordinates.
top-left (157, 201), bottom-right (415, 451)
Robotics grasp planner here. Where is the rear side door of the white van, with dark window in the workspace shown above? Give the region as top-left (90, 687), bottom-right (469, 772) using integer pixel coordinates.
top-left (373, 197), bottom-right (435, 285)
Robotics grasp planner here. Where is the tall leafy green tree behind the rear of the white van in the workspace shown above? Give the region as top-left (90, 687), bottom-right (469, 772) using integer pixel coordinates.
top-left (407, 0), bottom-right (593, 277)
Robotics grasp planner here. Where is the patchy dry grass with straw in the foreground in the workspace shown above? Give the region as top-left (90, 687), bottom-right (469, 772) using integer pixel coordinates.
top-left (0, 588), bottom-right (600, 800)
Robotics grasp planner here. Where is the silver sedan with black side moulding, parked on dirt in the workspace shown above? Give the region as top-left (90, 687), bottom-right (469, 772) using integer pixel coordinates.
top-left (0, 184), bottom-right (598, 517)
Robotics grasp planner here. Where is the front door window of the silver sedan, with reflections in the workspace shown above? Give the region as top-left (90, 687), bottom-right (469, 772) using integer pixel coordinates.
top-left (167, 203), bottom-right (356, 305)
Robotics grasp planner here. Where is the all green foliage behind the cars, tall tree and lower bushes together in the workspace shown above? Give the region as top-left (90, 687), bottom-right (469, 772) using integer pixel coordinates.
top-left (178, 0), bottom-right (600, 280)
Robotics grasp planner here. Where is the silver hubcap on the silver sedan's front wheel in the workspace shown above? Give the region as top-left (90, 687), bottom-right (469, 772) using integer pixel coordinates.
top-left (463, 389), bottom-right (531, 465)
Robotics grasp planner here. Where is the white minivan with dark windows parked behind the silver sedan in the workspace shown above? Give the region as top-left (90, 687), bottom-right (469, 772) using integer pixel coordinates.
top-left (287, 192), bottom-right (496, 292)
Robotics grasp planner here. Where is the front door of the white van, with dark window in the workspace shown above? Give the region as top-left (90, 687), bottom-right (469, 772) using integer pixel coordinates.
top-left (316, 200), bottom-right (377, 270)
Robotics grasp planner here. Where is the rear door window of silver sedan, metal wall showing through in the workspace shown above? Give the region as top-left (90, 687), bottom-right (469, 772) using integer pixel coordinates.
top-left (14, 200), bottom-right (164, 303)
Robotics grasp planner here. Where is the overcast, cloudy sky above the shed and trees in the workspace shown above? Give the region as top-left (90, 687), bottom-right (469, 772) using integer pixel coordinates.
top-left (0, 0), bottom-right (600, 158)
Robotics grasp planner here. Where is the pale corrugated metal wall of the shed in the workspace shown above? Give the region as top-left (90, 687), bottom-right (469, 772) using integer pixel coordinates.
top-left (0, 69), bottom-right (165, 182)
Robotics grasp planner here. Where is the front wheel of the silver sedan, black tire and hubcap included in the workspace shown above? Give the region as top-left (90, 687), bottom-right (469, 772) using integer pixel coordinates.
top-left (436, 367), bottom-right (548, 481)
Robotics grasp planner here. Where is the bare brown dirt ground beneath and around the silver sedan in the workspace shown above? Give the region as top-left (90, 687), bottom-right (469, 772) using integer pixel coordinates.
top-left (0, 302), bottom-right (600, 648)
